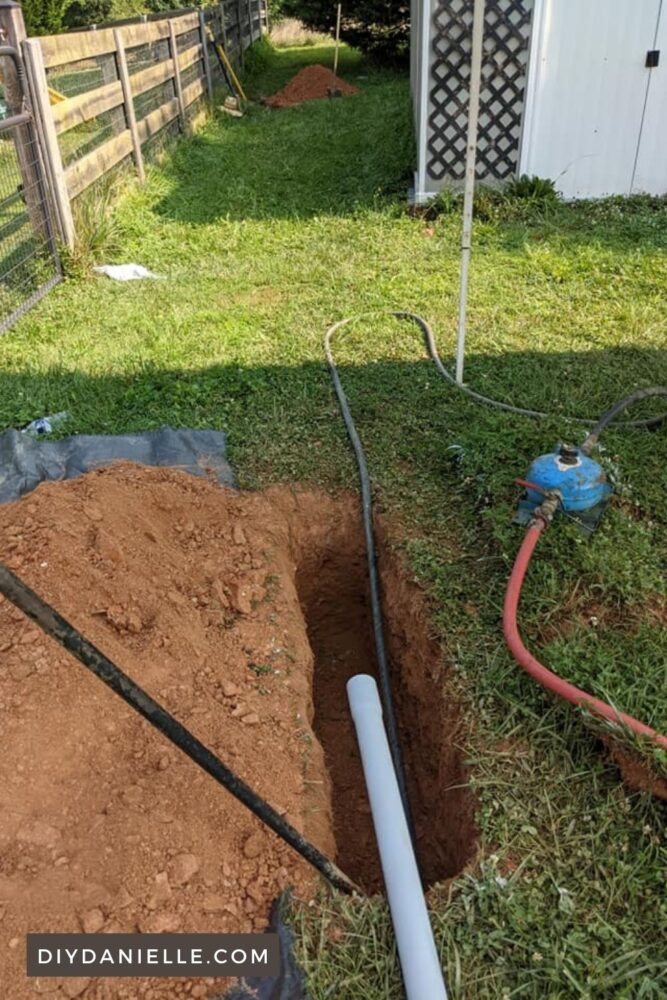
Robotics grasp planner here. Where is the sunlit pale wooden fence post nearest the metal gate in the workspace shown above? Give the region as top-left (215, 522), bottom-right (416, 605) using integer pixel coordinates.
top-left (22, 38), bottom-right (75, 247)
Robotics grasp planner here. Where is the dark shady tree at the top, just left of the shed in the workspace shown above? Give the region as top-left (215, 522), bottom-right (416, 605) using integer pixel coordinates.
top-left (282, 0), bottom-right (410, 62)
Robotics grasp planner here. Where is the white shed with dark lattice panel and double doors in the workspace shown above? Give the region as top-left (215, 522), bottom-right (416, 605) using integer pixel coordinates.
top-left (411, 0), bottom-right (667, 203)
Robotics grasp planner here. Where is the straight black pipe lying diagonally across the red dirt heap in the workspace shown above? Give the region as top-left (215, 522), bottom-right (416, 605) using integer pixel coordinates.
top-left (0, 563), bottom-right (359, 893)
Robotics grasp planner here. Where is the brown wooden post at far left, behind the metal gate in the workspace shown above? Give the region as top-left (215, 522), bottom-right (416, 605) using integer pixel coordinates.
top-left (0, 0), bottom-right (50, 240)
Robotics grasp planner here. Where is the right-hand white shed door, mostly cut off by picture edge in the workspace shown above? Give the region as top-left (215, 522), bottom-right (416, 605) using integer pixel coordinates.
top-left (632, 0), bottom-right (667, 194)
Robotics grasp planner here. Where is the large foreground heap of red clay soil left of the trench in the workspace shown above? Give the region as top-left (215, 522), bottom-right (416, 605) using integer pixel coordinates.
top-left (0, 466), bottom-right (334, 1000)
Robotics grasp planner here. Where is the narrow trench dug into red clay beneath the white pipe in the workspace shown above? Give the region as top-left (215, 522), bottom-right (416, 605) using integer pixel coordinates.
top-left (296, 508), bottom-right (477, 893)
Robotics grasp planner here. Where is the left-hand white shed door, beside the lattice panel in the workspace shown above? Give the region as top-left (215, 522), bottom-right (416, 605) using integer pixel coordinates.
top-left (521, 0), bottom-right (667, 198)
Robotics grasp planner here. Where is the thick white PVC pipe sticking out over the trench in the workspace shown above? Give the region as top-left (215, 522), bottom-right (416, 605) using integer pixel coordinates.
top-left (347, 674), bottom-right (447, 1000)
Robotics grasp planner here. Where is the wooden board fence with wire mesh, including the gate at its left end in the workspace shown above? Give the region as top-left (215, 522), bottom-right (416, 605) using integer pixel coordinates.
top-left (0, 0), bottom-right (264, 332)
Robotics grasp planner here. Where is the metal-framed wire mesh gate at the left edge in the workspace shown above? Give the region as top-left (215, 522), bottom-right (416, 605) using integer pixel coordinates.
top-left (0, 45), bottom-right (61, 333)
